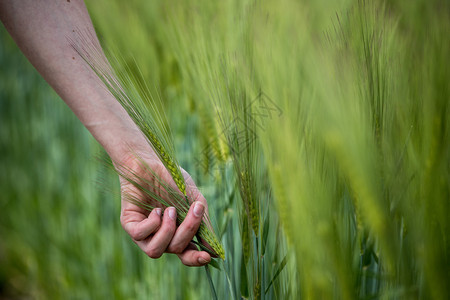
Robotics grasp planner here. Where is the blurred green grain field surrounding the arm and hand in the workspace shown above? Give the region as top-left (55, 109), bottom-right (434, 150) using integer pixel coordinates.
top-left (0, 0), bottom-right (450, 300)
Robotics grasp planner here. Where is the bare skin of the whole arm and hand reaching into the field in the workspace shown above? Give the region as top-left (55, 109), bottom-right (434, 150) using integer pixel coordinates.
top-left (0, 0), bottom-right (211, 266)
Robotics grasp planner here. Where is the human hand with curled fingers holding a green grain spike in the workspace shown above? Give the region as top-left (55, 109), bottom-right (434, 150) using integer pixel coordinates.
top-left (120, 155), bottom-right (211, 266)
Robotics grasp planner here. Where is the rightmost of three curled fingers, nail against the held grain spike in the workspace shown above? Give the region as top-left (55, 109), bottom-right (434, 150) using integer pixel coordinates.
top-left (167, 201), bottom-right (205, 253)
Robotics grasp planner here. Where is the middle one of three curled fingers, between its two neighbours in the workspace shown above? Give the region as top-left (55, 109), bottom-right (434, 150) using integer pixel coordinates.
top-left (138, 207), bottom-right (177, 258)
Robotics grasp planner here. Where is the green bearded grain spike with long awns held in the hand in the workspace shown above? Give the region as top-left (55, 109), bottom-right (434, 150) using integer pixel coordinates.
top-left (69, 30), bottom-right (225, 259)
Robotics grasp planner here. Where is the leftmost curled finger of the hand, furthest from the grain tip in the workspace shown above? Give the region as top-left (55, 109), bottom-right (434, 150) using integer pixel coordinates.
top-left (123, 208), bottom-right (161, 241)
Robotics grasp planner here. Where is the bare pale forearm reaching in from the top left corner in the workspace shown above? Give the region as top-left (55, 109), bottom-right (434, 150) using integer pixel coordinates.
top-left (0, 0), bottom-right (153, 163)
